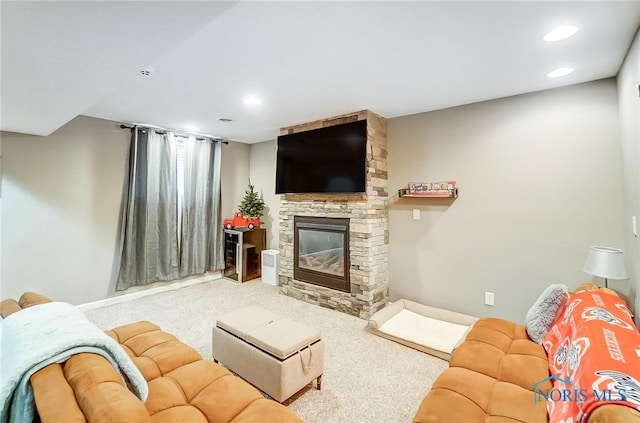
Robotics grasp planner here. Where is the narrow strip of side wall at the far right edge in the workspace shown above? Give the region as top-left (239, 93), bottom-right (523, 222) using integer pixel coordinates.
top-left (618, 29), bottom-right (640, 324)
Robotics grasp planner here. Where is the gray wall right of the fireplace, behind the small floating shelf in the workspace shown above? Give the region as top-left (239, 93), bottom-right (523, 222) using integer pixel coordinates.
top-left (388, 79), bottom-right (628, 321)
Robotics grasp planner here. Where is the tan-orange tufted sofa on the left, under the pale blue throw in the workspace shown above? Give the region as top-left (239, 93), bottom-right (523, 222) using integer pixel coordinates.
top-left (0, 293), bottom-right (302, 423)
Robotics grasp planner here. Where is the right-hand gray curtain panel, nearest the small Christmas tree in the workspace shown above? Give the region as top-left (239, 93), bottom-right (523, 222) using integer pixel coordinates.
top-left (180, 137), bottom-right (224, 277)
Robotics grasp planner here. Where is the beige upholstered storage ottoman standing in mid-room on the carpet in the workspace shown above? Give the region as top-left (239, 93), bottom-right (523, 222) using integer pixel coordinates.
top-left (213, 306), bottom-right (324, 402)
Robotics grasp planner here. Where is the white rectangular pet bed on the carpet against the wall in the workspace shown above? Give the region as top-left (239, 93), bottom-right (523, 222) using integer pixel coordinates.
top-left (369, 300), bottom-right (478, 360)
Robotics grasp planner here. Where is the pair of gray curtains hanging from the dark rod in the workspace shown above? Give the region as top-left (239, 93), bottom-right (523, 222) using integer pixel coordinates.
top-left (116, 127), bottom-right (224, 291)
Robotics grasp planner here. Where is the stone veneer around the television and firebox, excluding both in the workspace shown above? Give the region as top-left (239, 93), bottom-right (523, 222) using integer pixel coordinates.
top-left (279, 110), bottom-right (389, 319)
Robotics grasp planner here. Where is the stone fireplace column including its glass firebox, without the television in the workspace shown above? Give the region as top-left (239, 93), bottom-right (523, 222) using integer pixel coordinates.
top-left (279, 110), bottom-right (389, 319)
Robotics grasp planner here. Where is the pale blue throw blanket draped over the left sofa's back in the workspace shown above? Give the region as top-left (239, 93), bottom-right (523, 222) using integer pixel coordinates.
top-left (0, 302), bottom-right (148, 423)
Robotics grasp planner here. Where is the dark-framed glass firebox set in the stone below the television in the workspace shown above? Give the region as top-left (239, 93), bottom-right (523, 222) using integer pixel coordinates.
top-left (293, 216), bottom-right (350, 292)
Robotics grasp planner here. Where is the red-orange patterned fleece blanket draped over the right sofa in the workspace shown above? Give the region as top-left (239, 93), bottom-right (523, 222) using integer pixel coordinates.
top-left (536, 291), bottom-right (640, 423)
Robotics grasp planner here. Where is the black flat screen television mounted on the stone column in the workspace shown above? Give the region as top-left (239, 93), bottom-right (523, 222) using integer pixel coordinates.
top-left (276, 120), bottom-right (367, 194)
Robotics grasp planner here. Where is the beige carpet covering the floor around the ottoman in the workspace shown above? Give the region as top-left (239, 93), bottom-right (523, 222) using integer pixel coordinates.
top-left (85, 279), bottom-right (447, 423)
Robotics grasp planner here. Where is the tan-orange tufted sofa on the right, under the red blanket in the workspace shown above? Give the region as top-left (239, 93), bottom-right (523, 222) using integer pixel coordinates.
top-left (413, 284), bottom-right (640, 423)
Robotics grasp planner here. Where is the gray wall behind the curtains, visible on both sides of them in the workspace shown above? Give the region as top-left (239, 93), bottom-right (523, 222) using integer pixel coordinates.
top-left (0, 116), bottom-right (249, 304)
